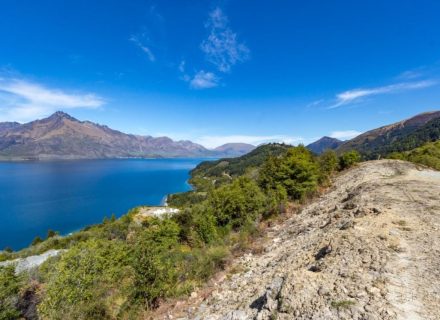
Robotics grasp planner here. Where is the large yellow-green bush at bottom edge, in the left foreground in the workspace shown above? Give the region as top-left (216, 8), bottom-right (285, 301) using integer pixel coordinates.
top-left (38, 240), bottom-right (132, 319)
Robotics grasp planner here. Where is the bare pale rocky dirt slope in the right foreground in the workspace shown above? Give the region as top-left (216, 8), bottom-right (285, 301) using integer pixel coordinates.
top-left (166, 160), bottom-right (440, 320)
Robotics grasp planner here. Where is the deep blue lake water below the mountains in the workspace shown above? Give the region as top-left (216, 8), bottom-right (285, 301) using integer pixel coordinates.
top-left (0, 159), bottom-right (204, 250)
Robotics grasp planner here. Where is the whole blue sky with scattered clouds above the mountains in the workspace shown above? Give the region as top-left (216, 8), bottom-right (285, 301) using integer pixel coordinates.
top-left (0, 0), bottom-right (440, 147)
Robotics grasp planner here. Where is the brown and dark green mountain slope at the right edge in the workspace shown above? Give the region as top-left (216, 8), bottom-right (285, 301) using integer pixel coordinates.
top-left (337, 111), bottom-right (440, 159)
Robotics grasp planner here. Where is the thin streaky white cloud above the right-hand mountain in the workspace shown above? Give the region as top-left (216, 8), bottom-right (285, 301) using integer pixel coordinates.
top-left (328, 80), bottom-right (437, 109)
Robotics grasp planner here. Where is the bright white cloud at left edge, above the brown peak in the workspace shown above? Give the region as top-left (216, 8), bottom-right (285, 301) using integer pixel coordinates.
top-left (0, 78), bottom-right (105, 121)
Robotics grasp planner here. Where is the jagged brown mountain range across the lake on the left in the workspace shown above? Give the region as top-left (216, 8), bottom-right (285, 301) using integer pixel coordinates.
top-left (0, 112), bottom-right (251, 160)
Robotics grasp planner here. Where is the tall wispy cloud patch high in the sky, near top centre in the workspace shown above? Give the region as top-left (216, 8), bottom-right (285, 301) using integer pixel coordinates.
top-left (200, 8), bottom-right (249, 72)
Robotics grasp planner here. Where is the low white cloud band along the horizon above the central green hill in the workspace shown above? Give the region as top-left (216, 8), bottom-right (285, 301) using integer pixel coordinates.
top-left (194, 135), bottom-right (304, 148)
